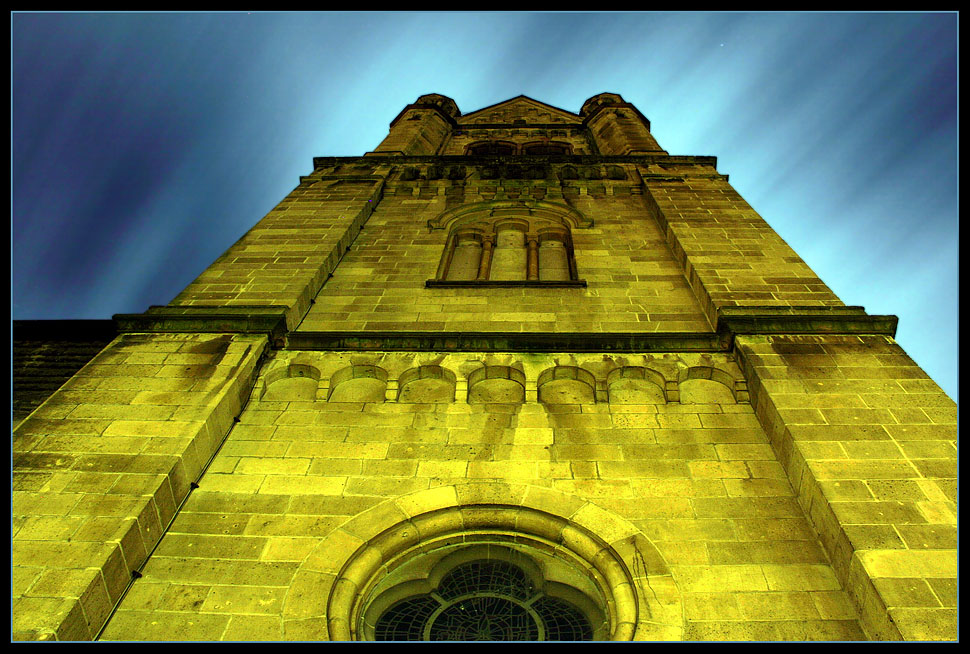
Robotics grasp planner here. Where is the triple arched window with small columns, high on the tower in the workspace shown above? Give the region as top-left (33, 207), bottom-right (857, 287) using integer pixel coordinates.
top-left (428, 211), bottom-right (586, 286)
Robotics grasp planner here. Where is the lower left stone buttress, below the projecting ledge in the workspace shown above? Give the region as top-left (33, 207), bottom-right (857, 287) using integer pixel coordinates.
top-left (11, 334), bottom-right (265, 640)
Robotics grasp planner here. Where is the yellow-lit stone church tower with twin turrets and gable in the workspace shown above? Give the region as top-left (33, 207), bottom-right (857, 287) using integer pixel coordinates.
top-left (12, 93), bottom-right (957, 641)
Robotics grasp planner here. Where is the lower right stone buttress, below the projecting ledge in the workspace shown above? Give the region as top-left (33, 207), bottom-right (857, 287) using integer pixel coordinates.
top-left (738, 335), bottom-right (957, 640)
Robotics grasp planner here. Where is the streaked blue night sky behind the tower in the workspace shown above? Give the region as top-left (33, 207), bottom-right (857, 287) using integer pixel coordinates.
top-left (11, 13), bottom-right (959, 399)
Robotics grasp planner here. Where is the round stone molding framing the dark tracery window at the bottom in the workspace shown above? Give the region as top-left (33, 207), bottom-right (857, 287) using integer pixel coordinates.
top-left (283, 482), bottom-right (684, 641)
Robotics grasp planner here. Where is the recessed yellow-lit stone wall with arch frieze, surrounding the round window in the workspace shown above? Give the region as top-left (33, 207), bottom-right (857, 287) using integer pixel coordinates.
top-left (105, 352), bottom-right (864, 640)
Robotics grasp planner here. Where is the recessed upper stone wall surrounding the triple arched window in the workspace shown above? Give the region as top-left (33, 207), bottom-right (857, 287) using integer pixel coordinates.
top-left (299, 165), bottom-right (711, 332)
